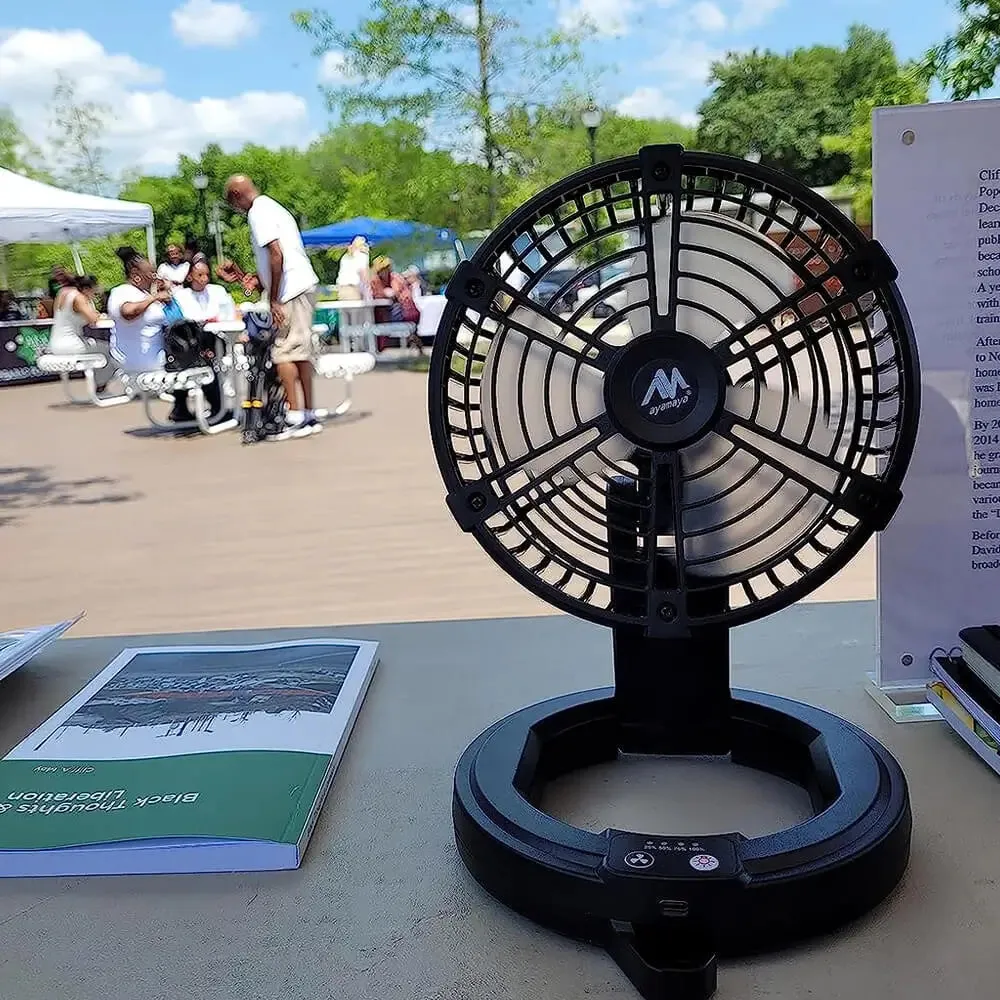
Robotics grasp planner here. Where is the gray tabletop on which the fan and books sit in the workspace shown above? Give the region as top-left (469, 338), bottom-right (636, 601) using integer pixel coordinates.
top-left (0, 603), bottom-right (1000, 1000)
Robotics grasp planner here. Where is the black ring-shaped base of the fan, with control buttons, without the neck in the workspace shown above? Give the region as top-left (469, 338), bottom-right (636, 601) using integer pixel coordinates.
top-left (453, 688), bottom-right (911, 1000)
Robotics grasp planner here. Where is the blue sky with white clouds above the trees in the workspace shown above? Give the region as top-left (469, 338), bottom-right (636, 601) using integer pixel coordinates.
top-left (0, 0), bottom-right (956, 173)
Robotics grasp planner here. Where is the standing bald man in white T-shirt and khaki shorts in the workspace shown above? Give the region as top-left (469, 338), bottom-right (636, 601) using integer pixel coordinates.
top-left (217, 174), bottom-right (323, 436)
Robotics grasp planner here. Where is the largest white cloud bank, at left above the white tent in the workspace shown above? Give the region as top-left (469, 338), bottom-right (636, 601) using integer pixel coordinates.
top-left (0, 30), bottom-right (309, 172)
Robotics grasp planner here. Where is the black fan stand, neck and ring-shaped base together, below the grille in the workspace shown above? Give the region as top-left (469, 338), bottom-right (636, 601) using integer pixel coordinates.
top-left (453, 470), bottom-right (910, 1000)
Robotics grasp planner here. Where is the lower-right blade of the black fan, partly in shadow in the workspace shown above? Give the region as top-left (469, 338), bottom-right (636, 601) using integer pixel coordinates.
top-left (681, 386), bottom-right (838, 576)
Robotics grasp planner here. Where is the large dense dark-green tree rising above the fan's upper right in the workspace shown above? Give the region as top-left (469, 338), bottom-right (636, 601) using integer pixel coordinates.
top-left (698, 25), bottom-right (916, 187)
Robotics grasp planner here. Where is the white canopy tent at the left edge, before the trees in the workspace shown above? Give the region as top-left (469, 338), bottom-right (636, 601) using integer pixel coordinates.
top-left (0, 168), bottom-right (156, 267)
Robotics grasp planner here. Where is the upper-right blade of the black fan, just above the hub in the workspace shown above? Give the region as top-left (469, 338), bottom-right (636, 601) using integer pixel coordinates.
top-left (626, 212), bottom-right (795, 345)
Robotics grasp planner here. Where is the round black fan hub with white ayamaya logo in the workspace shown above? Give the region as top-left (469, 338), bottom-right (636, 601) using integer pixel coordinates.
top-left (604, 331), bottom-right (726, 448)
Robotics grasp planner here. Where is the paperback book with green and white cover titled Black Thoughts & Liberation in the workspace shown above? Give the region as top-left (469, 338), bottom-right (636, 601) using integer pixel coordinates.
top-left (0, 639), bottom-right (378, 877)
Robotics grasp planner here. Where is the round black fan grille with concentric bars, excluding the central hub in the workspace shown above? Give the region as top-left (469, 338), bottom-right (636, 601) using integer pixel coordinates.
top-left (430, 147), bottom-right (919, 629)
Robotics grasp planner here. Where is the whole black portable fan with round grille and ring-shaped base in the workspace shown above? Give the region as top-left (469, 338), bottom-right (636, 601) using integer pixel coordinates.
top-left (430, 146), bottom-right (919, 998)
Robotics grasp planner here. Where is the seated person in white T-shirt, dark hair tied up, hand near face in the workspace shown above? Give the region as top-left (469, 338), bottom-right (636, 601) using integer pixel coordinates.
top-left (108, 247), bottom-right (172, 372)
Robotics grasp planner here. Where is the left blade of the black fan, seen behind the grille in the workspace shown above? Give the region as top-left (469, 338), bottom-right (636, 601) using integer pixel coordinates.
top-left (480, 306), bottom-right (633, 483)
